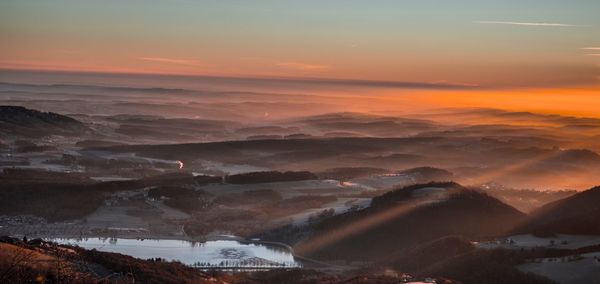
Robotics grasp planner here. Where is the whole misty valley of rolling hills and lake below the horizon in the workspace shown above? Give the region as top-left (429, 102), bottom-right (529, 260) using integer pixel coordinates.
top-left (0, 76), bottom-right (600, 284)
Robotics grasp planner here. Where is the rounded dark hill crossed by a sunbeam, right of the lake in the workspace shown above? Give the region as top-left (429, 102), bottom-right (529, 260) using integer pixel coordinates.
top-left (296, 183), bottom-right (525, 260)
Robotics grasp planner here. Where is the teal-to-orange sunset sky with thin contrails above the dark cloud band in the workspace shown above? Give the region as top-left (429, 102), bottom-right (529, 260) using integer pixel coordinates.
top-left (0, 0), bottom-right (600, 115)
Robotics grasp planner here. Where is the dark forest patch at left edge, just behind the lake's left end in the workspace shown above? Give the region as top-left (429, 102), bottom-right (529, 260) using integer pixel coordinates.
top-left (0, 169), bottom-right (220, 221)
